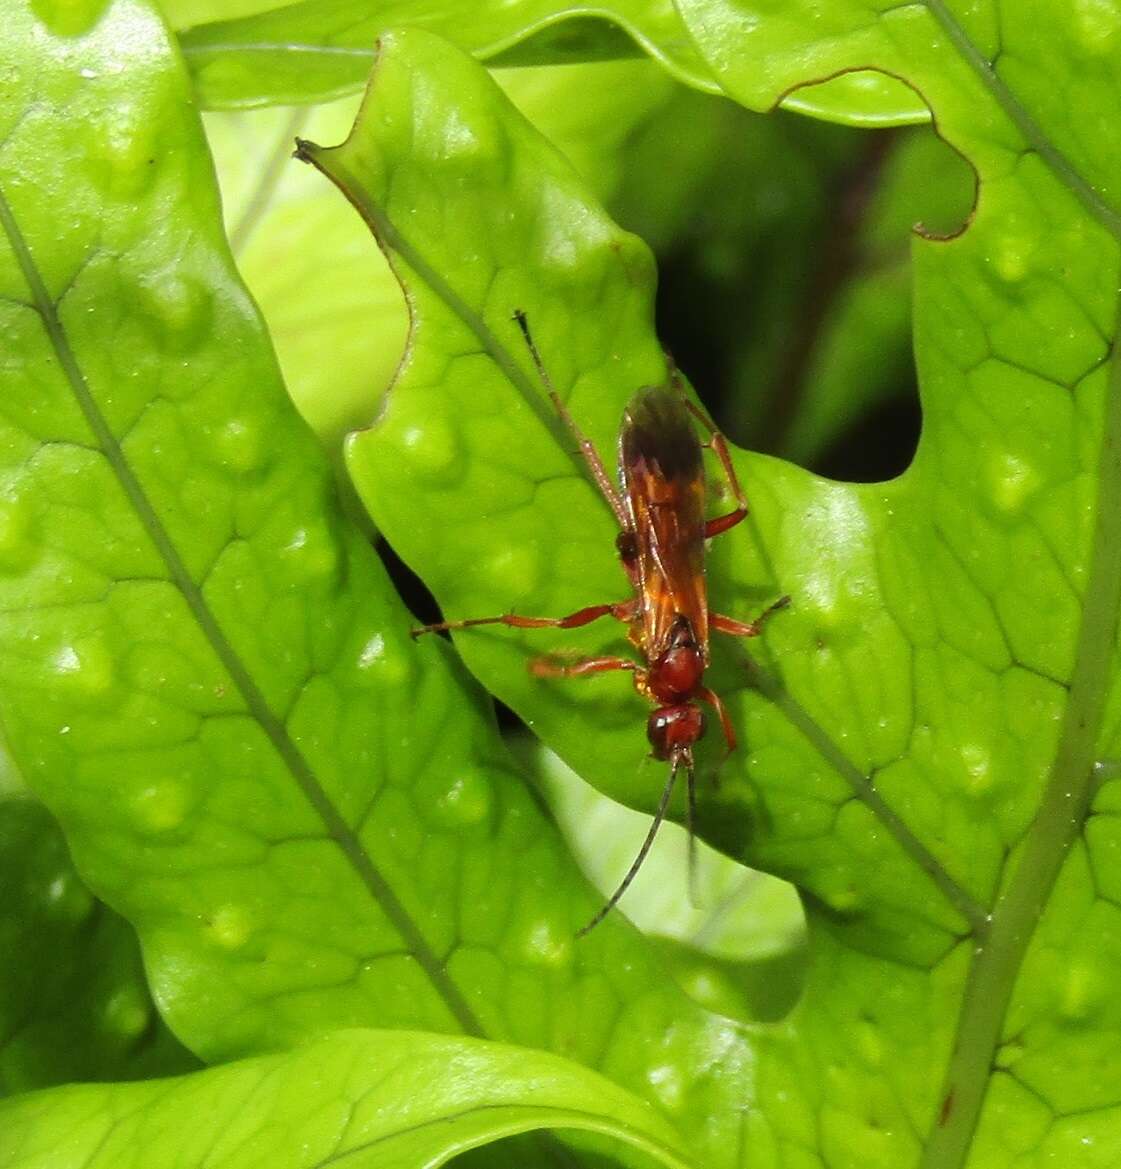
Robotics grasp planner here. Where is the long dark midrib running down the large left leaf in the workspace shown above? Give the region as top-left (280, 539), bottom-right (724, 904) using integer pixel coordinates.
top-left (0, 188), bottom-right (485, 1037)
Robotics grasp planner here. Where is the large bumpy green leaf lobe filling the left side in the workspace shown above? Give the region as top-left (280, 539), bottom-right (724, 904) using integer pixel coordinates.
top-left (0, 11), bottom-right (766, 1165)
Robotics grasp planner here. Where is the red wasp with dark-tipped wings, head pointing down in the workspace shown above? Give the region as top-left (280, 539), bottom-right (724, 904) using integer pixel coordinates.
top-left (411, 311), bottom-right (790, 936)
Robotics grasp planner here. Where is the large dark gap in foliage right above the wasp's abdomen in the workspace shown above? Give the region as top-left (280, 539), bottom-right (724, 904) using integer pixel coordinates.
top-left (657, 106), bottom-right (975, 482)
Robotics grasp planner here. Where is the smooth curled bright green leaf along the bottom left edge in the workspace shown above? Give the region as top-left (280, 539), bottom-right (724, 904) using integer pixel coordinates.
top-left (0, 1031), bottom-right (685, 1169)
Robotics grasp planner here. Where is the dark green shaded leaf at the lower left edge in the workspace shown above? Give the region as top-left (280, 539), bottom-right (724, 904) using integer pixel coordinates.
top-left (0, 800), bottom-right (195, 1095)
